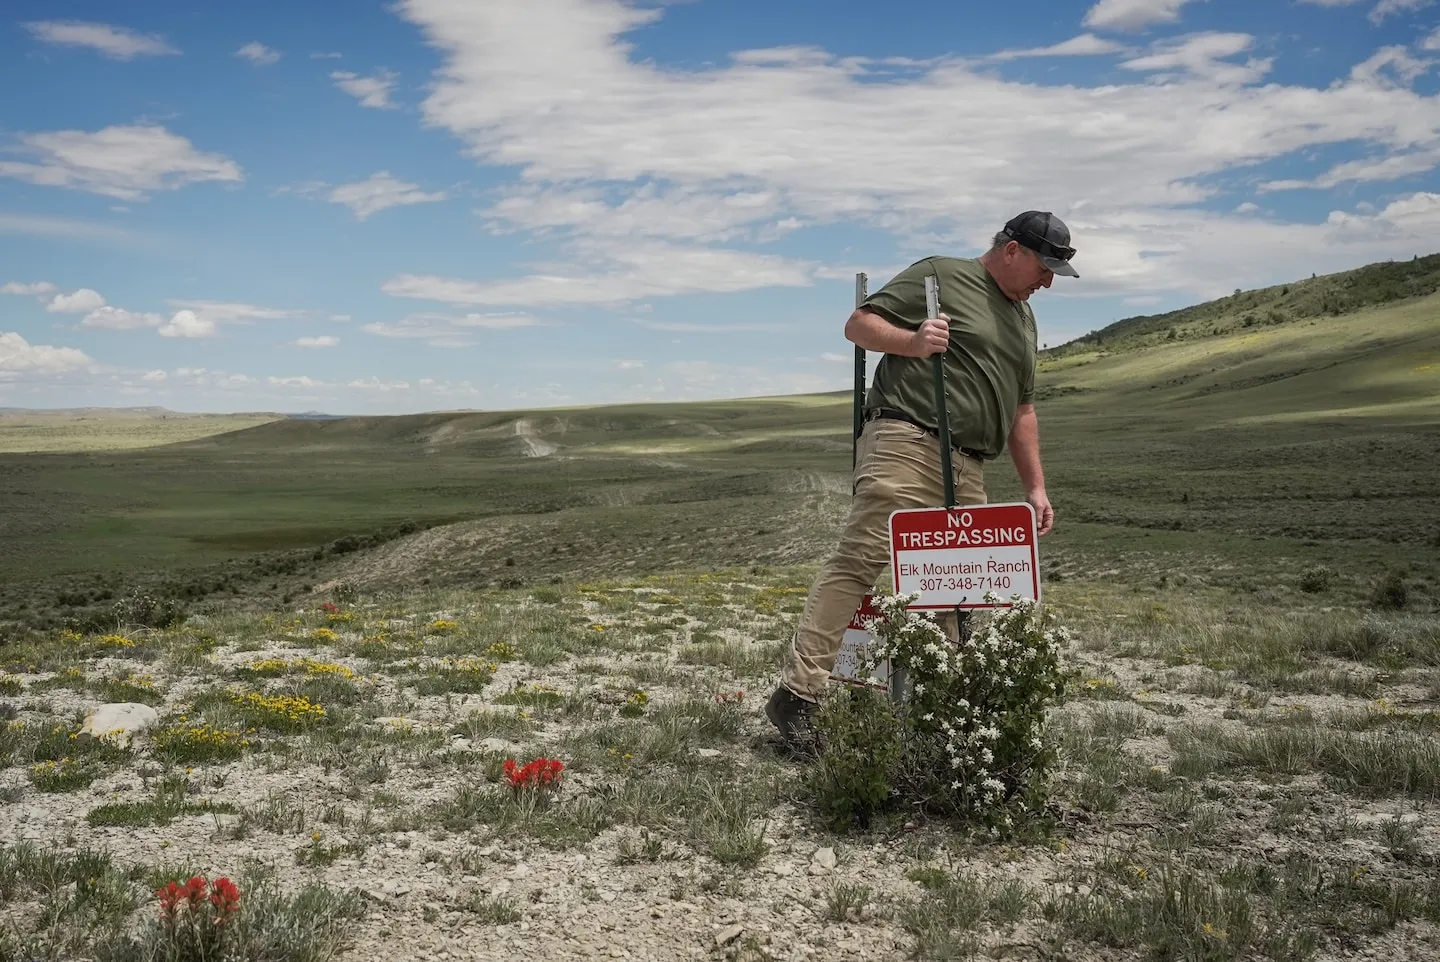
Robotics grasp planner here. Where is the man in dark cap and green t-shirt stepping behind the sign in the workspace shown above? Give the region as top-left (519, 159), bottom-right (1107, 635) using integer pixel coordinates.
top-left (765, 210), bottom-right (1080, 755)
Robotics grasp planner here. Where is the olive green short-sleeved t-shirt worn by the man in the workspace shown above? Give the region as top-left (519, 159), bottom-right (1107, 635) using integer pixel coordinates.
top-left (863, 256), bottom-right (1035, 458)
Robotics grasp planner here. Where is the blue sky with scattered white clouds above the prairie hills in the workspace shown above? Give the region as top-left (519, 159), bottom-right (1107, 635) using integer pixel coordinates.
top-left (0, 0), bottom-right (1440, 413)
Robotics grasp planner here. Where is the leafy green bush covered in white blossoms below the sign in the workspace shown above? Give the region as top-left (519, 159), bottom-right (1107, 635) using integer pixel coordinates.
top-left (821, 593), bottom-right (1070, 830)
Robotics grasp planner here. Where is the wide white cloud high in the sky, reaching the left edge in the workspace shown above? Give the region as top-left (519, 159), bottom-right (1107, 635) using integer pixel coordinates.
top-left (0, 124), bottom-right (243, 200)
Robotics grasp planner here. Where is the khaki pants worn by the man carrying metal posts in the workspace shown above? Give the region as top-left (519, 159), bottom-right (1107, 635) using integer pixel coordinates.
top-left (780, 419), bottom-right (985, 701)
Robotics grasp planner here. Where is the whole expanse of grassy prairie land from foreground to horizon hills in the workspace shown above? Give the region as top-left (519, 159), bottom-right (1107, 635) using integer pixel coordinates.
top-left (0, 259), bottom-right (1440, 961)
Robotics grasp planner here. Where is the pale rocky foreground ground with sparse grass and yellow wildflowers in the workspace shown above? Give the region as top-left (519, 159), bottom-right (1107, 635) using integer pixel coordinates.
top-left (0, 570), bottom-right (1440, 962)
